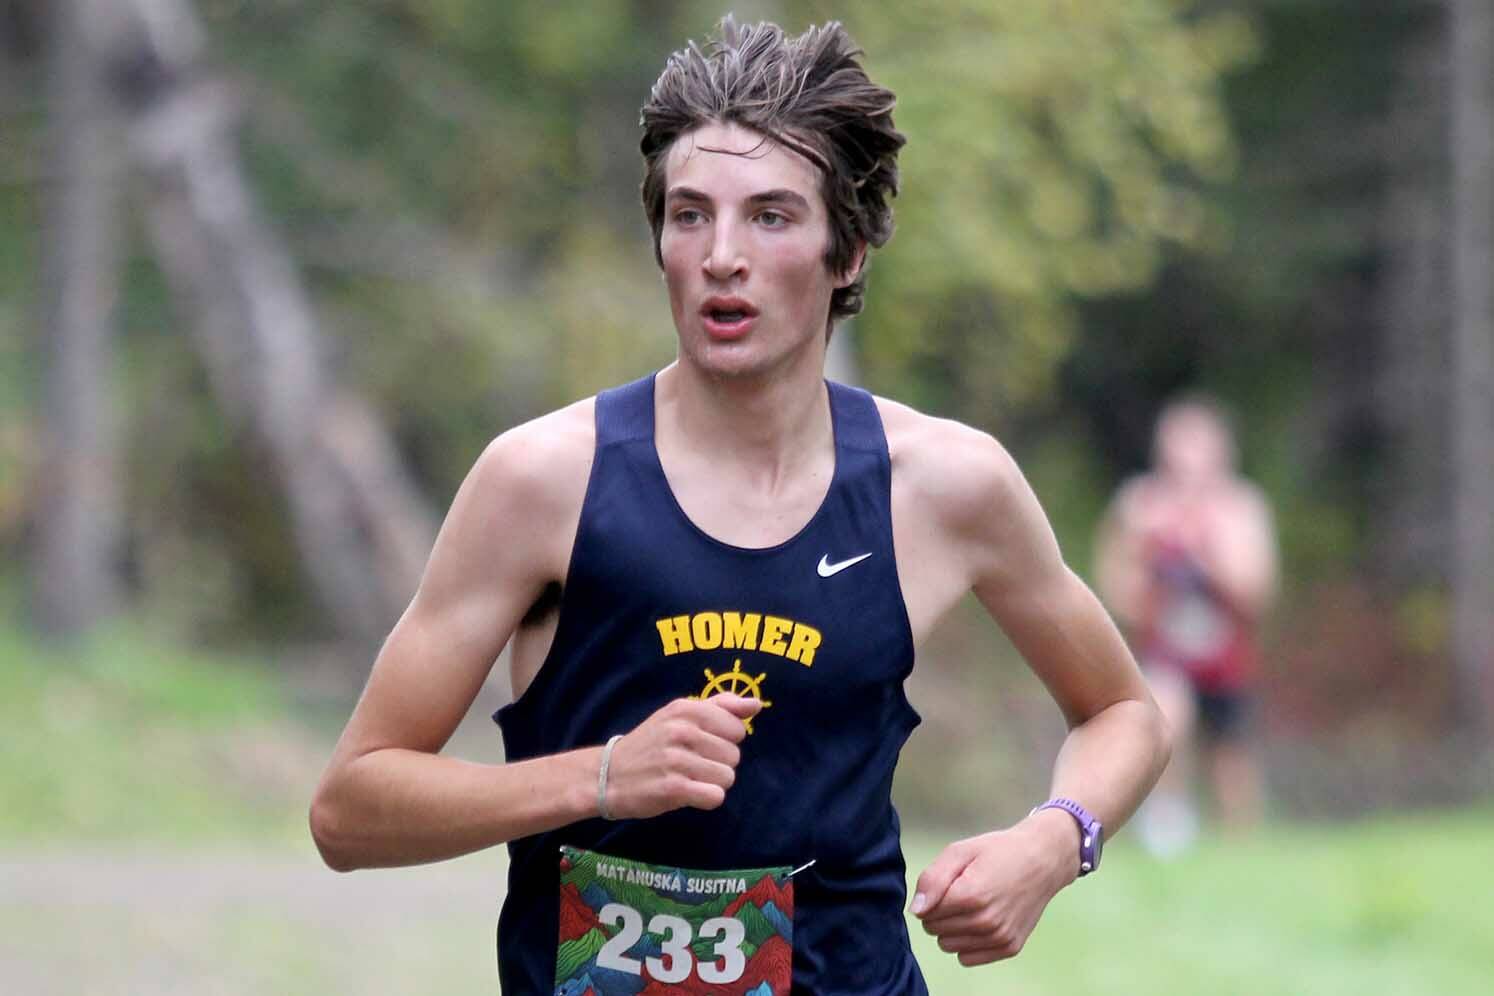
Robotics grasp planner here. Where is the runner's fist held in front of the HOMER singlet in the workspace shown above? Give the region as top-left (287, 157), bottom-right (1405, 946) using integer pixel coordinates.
top-left (607, 694), bottom-right (762, 820)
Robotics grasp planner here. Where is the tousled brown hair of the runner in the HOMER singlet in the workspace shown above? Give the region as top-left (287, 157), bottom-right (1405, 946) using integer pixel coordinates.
top-left (639, 15), bottom-right (905, 324)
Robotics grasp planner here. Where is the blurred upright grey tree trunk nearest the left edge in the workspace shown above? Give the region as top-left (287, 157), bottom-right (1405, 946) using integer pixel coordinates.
top-left (33, 0), bottom-right (123, 635)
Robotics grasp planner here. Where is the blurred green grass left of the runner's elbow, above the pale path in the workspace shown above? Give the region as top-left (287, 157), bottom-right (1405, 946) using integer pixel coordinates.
top-left (0, 626), bottom-right (315, 845)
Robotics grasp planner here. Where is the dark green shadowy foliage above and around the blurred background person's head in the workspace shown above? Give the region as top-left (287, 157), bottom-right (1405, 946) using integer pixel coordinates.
top-left (1056, 0), bottom-right (1442, 591)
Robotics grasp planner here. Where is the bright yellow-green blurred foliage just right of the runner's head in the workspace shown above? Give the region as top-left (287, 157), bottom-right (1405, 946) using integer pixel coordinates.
top-left (830, 0), bottom-right (1256, 424)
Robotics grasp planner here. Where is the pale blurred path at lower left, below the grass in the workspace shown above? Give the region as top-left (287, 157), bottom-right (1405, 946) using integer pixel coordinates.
top-left (0, 847), bottom-right (506, 996)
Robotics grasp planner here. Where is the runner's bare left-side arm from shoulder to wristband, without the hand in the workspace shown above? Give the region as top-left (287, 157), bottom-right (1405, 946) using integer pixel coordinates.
top-left (311, 429), bottom-right (601, 871)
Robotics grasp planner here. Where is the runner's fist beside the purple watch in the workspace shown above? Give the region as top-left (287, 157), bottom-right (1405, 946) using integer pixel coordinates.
top-left (911, 811), bottom-right (1079, 965)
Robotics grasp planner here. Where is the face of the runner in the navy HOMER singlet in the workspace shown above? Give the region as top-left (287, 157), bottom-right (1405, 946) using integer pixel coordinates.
top-left (659, 124), bottom-right (850, 376)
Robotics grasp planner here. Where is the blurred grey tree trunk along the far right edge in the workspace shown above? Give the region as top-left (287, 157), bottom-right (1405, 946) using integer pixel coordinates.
top-left (1448, 0), bottom-right (1494, 733)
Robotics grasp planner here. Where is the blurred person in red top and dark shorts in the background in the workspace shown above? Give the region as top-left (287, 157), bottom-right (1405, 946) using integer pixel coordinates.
top-left (1098, 396), bottom-right (1276, 854)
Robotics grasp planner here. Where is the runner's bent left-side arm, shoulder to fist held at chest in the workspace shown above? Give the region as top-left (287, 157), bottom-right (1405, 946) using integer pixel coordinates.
top-left (311, 408), bottom-right (759, 871)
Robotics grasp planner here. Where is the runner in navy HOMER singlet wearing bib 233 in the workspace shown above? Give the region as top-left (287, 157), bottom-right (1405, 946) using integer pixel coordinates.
top-left (311, 19), bottom-right (1168, 996)
